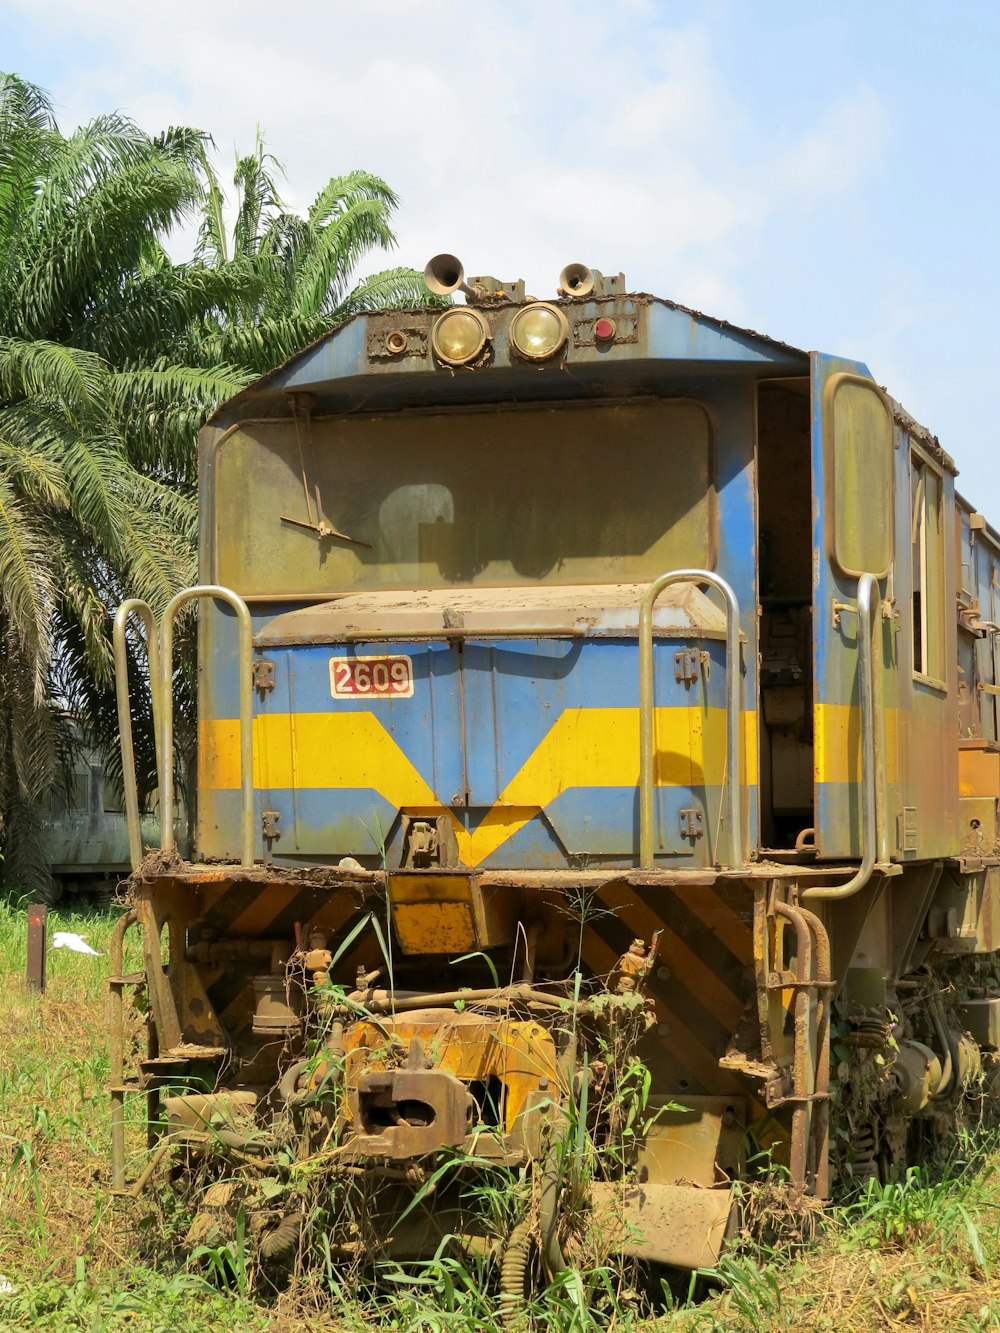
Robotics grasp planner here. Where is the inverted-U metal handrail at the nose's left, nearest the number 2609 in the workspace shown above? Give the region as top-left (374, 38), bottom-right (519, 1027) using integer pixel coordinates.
top-left (160, 584), bottom-right (253, 865)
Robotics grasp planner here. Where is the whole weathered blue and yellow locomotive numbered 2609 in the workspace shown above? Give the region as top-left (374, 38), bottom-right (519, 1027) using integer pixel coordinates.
top-left (111, 256), bottom-right (1000, 1293)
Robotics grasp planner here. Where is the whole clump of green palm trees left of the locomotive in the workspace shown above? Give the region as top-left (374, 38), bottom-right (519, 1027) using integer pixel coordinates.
top-left (0, 75), bottom-right (428, 881)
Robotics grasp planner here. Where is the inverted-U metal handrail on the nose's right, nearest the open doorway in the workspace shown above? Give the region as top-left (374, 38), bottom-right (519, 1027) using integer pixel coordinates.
top-left (639, 569), bottom-right (743, 866)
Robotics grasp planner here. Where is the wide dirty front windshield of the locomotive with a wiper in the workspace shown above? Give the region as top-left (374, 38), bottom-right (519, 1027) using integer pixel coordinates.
top-left (212, 399), bottom-right (715, 596)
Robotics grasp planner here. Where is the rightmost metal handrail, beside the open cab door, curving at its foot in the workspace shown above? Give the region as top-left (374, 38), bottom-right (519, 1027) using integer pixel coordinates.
top-left (800, 575), bottom-right (888, 900)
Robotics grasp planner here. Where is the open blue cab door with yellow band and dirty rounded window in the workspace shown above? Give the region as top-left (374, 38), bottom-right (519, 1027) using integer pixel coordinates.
top-left (811, 353), bottom-right (897, 858)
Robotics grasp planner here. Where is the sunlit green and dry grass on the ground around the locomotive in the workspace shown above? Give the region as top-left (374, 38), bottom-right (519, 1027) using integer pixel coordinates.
top-left (0, 898), bottom-right (1000, 1333)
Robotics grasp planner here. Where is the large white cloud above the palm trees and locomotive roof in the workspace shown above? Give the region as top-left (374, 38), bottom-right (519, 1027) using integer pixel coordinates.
top-left (11, 0), bottom-right (887, 320)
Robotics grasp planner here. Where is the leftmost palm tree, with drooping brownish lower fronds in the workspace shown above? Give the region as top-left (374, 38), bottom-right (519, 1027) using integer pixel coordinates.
top-left (0, 75), bottom-right (213, 882)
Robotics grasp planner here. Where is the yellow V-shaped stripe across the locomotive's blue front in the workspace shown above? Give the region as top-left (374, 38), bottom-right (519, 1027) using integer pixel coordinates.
top-left (199, 708), bottom-right (757, 865)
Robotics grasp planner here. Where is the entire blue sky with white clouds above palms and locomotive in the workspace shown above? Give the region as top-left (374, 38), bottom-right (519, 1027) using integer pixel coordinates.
top-left (7, 0), bottom-right (1000, 524)
